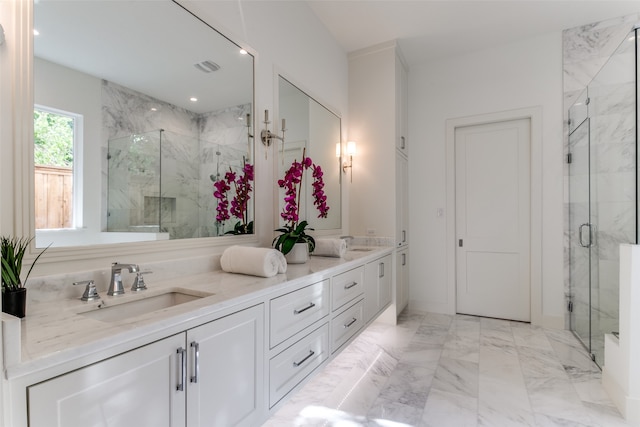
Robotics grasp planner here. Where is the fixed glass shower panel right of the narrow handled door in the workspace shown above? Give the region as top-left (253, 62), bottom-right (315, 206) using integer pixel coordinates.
top-left (588, 29), bottom-right (637, 366)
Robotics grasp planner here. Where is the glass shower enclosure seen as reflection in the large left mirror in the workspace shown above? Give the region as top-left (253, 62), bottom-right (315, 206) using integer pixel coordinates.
top-left (107, 128), bottom-right (253, 240)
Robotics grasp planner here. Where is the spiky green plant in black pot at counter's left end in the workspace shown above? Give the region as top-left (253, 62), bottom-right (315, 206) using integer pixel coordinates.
top-left (0, 236), bottom-right (46, 318)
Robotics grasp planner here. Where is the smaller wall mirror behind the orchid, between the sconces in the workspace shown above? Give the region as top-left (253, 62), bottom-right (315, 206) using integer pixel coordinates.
top-left (276, 76), bottom-right (342, 232)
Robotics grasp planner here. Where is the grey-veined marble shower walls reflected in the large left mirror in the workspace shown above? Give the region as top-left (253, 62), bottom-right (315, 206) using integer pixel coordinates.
top-left (102, 81), bottom-right (252, 239)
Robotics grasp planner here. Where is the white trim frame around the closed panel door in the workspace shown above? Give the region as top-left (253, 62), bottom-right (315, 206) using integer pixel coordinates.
top-left (445, 107), bottom-right (544, 327)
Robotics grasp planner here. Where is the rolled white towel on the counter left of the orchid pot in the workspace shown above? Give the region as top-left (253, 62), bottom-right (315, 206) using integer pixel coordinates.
top-left (220, 246), bottom-right (287, 277)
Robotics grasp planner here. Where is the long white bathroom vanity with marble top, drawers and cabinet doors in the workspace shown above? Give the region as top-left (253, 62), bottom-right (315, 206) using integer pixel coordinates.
top-left (3, 247), bottom-right (395, 427)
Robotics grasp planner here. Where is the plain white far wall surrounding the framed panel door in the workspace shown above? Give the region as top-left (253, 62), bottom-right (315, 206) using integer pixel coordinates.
top-left (409, 32), bottom-right (563, 326)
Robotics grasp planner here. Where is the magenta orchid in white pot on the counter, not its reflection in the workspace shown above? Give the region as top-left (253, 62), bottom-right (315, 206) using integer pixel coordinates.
top-left (272, 150), bottom-right (329, 264)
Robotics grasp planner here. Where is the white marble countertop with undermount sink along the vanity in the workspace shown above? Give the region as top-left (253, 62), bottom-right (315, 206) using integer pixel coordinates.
top-left (3, 247), bottom-right (393, 379)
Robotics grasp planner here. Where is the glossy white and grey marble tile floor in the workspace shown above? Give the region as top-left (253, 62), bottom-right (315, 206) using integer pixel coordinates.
top-left (265, 311), bottom-right (627, 427)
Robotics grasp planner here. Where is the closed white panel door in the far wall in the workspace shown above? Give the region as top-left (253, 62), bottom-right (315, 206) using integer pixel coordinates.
top-left (455, 119), bottom-right (531, 322)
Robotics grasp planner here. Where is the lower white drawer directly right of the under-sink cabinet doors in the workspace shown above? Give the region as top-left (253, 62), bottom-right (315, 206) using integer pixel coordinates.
top-left (269, 323), bottom-right (329, 408)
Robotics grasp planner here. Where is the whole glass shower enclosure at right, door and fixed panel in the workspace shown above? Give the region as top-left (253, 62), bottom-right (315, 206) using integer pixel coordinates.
top-left (567, 30), bottom-right (638, 367)
